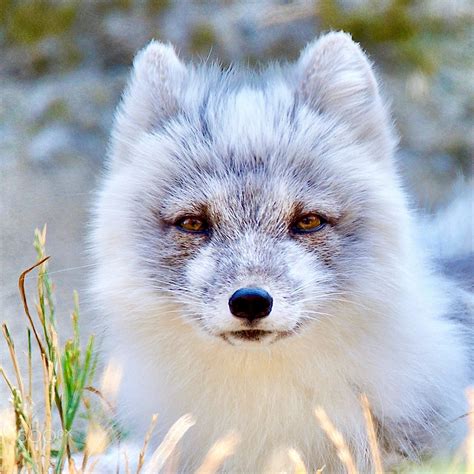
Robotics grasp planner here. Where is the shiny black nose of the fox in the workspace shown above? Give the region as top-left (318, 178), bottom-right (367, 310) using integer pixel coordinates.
top-left (229, 288), bottom-right (273, 321)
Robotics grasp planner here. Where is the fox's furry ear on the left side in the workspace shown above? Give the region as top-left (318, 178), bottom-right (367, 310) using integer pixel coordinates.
top-left (112, 41), bottom-right (186, 167)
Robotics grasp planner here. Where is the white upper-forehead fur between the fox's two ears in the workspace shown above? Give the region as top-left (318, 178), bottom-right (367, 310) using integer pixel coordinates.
top-left (173, 77), bottom-right (354, 163)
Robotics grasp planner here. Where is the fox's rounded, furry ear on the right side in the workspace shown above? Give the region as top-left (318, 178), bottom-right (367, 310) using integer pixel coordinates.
top-left (297, 32), bottom-right (392, 146)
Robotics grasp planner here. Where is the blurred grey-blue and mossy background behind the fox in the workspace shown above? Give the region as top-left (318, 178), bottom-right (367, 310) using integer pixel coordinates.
top-left (0, 0), bottom-right (474, 390)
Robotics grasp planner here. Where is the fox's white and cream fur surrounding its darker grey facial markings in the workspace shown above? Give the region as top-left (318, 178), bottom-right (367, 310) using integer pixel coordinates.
top-left (92, 33), bottom-right (469, 472)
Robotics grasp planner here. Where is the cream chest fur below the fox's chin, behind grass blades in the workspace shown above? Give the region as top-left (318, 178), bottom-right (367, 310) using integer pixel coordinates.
top-left (120, 358), bottom-right (364, 472)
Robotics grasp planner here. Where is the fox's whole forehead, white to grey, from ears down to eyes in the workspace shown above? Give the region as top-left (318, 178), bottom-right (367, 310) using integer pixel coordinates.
top-left (143, 85), bottom-right (357, 204)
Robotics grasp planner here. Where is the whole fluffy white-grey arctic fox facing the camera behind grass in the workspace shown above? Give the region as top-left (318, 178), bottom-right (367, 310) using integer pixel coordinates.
top-left (92, 33), bottom-right (473, 473)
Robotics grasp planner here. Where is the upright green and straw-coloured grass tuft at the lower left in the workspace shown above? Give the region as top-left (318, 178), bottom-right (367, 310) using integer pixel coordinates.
top-left (0, 226), bottom-right (96, 473)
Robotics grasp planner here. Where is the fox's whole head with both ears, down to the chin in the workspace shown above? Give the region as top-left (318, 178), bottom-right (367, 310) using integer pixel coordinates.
top-left (93, 33), bottom-right (408, 350)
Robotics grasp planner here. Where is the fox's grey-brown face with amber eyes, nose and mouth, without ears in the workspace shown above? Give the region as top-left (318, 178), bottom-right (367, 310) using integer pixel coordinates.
top-left (133, 140), bottom-right (344, 344)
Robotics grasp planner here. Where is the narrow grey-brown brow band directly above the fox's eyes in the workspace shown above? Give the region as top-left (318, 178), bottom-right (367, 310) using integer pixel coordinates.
top-left (159, 165), bottom-right (341, 223)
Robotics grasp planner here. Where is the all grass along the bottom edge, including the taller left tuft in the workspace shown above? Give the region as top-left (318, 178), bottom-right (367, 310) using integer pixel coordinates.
top-left (0, 228), bottom-right (474, 474)
